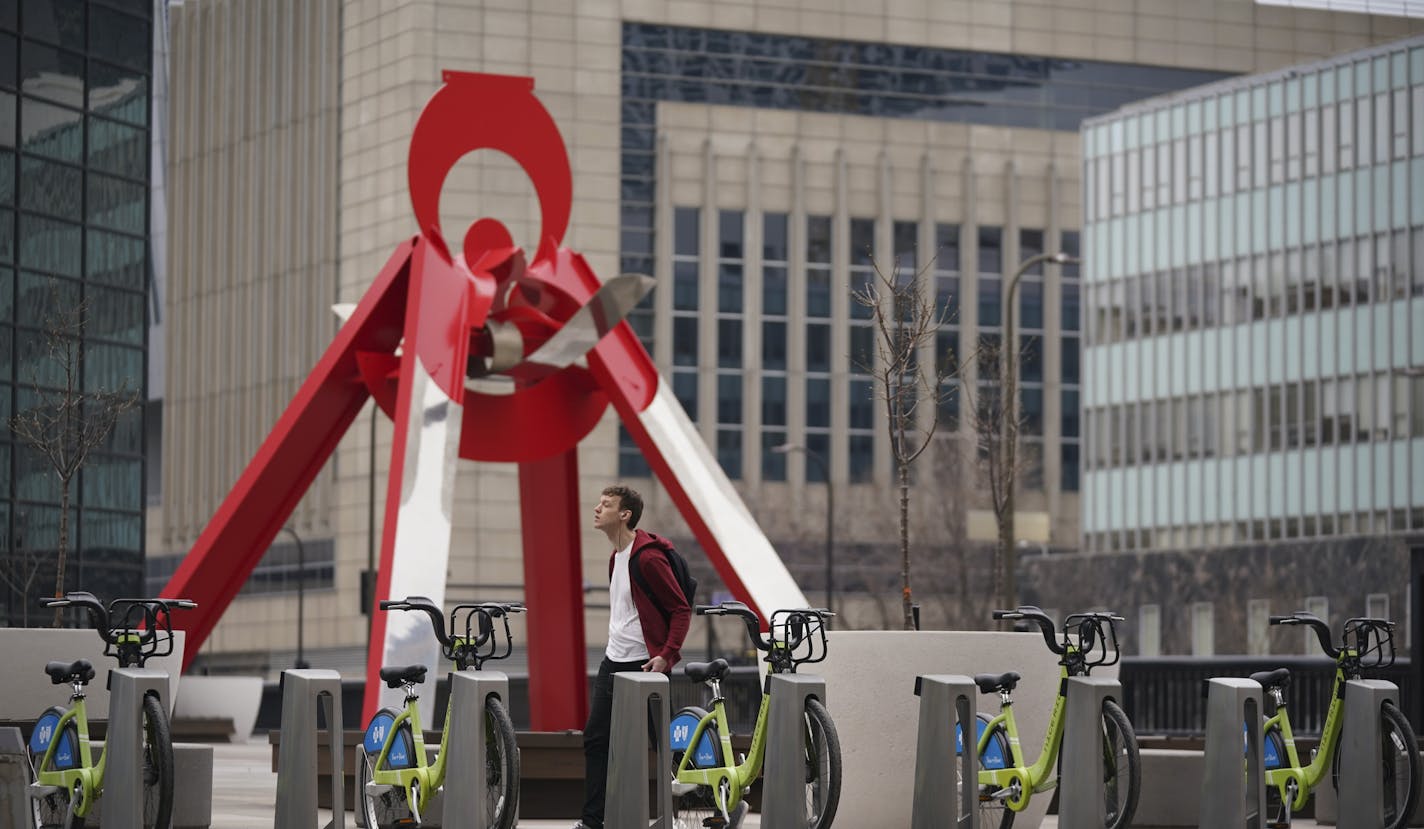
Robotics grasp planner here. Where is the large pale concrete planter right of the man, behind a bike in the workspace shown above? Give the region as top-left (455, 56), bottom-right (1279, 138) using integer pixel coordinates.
top-left (805, 631), bottom-right (1111, 829)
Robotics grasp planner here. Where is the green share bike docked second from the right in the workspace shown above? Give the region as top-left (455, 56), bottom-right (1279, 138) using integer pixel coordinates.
top-left (954, 605), bottom-right (1142, 829)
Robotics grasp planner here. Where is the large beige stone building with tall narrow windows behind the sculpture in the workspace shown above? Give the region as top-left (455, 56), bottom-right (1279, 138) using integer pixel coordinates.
top-left (150, 0), bottom-right (1417, 669)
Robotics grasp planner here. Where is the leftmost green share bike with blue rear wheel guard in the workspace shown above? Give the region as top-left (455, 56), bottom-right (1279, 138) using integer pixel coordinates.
top-left (30, 591), bottom-right (198, 829)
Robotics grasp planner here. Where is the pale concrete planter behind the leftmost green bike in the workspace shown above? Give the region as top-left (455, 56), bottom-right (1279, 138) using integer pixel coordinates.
top-left (0, 628), bottom-right (184, 721)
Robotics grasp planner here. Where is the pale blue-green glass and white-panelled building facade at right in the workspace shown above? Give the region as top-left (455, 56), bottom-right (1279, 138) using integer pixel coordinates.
top-left (1082, 38), bottom-right (1424, 550)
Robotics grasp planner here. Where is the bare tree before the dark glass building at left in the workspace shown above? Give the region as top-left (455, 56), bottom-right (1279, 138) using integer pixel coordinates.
top-left (10, 289), bottom-right (138, 627)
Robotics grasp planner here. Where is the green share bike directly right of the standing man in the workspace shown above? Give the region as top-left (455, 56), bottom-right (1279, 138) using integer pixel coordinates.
top-left (671, 601), bottom-right (840, 829)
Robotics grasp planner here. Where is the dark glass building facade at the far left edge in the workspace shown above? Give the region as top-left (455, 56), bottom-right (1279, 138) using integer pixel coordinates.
top-left (0, 0), bottom-right (152, 624)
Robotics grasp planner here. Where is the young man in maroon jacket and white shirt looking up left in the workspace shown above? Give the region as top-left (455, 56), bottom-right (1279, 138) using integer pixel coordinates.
top-left (574, 484), bottom-right (692, 829)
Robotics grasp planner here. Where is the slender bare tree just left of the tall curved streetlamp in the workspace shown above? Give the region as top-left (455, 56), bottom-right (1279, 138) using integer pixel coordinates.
top-left (852, 253), bottom-right (950, 630)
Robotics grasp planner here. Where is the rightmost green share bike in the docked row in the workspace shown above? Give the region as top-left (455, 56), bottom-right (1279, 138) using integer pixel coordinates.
top-left (1250, 611), bottom-right (1420, 829)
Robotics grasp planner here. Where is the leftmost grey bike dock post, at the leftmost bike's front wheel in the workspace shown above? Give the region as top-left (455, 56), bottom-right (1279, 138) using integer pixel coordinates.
top-left (104, 668), bottom-right (171, 826)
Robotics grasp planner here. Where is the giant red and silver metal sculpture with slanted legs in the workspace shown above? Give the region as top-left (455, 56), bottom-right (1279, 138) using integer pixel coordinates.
top-left (164, 71), bottom-right (805, 731)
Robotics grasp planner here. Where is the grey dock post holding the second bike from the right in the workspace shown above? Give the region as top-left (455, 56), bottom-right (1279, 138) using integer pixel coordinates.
top-left (1058, 677), bottom-right (1122, 829)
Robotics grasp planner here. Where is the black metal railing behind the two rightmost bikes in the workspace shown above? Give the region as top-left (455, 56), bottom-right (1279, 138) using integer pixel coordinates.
top-left (1121, 657), bottom-right (1414, 736)
